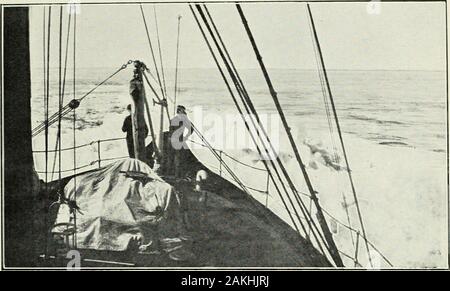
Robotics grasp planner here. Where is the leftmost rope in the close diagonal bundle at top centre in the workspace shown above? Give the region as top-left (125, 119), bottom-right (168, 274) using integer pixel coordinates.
top-left (189, 5), bottom-right (308, 242)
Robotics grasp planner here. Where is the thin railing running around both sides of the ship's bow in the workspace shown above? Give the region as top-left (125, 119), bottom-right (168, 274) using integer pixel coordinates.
top-left (33, 137), bottom-right (393, 267)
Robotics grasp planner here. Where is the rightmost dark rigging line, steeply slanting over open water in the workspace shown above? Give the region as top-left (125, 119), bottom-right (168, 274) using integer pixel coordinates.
top-left (306, 4), bottom-right (373, 266)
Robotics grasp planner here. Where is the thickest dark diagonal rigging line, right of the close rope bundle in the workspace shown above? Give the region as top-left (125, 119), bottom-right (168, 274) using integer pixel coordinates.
top-left (236, 4), bottom-right (343, 267)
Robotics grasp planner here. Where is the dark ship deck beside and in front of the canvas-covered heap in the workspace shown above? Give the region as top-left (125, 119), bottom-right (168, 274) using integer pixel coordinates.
top-left (37, 149), bottom-right (331, 268)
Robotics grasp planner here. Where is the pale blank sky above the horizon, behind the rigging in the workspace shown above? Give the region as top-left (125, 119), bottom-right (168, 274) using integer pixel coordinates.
top-left (30, 2), bottom-right (446, 70)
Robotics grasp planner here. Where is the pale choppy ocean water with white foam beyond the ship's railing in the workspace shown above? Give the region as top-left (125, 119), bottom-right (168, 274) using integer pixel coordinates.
top-left (32, 64), bottom-right (448, 268)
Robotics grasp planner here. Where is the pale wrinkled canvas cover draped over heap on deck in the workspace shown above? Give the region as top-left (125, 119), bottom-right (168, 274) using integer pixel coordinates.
top-left (56, 159), bottom-right (181, 251)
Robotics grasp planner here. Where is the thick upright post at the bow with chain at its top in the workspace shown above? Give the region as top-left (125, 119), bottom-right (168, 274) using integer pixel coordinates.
top-left (130, 61), bottom-right (147, 162)
